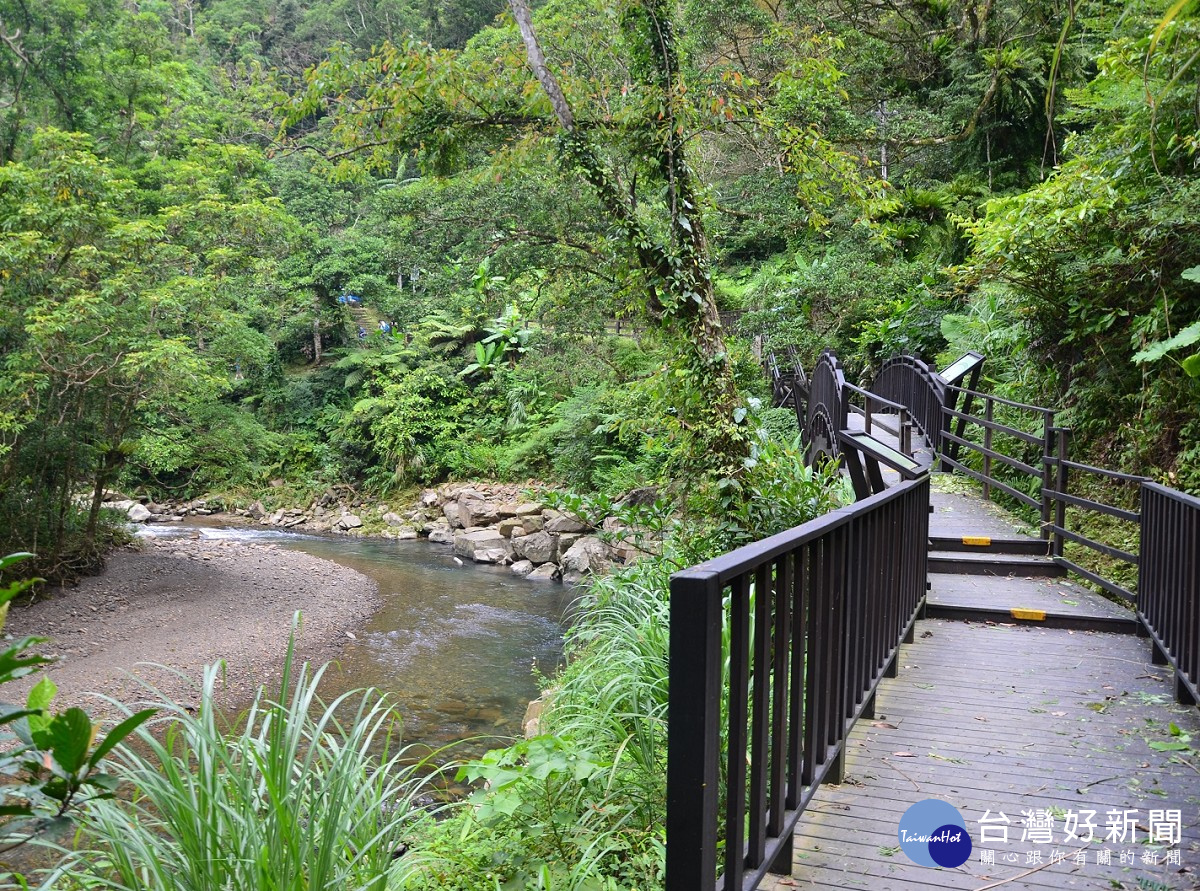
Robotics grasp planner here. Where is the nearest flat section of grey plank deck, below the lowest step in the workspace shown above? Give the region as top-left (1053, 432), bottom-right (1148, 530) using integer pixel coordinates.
top-left (761, 619), bottom-right (1200, 891)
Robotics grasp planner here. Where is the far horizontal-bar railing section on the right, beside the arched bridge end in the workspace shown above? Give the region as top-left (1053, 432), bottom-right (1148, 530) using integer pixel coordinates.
top-left (942, 384), bottom-right (1056, 538)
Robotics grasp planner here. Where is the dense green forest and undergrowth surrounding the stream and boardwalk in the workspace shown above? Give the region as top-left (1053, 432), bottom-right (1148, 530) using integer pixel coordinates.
top-left (0, 0), bottom-right (1200, 891)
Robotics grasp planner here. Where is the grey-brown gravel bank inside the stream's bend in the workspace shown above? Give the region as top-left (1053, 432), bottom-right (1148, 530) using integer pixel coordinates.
top-left (0, 538), bottom-right (379, 718)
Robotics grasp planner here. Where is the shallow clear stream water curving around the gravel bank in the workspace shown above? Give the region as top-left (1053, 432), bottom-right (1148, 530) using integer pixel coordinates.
top-left (146, 526), bottom-right (574, 760)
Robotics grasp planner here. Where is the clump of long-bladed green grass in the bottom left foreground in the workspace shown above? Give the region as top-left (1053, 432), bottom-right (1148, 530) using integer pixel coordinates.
top-left (52, 646), bottom-right (427, 891)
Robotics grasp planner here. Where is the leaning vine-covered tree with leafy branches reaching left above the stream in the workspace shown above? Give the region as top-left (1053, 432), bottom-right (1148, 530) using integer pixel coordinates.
top-left (288, 1), bottom-right (745, 474)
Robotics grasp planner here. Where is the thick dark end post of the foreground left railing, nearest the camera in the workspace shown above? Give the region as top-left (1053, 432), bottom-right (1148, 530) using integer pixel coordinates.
top-left (666, 572), bottom-right (722, 891)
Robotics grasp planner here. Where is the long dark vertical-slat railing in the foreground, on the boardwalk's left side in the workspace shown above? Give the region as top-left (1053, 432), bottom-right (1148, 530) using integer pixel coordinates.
top-left (666, 476), bottom-right (929, 891)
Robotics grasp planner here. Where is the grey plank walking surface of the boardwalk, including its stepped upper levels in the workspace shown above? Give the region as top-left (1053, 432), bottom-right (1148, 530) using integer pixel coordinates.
top-left (760, 485), bottom-right (1200, 891)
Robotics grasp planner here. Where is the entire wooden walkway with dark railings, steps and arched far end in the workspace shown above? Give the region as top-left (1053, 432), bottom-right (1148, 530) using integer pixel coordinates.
top-left (666, 352), bottom-right (1200, 891)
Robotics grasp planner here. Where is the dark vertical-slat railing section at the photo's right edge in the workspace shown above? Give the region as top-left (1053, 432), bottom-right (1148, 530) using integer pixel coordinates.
top-left (1138, 483), bottom-right (1200, 704)
